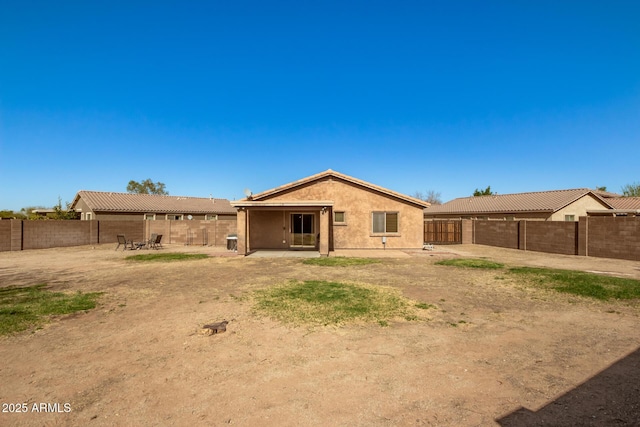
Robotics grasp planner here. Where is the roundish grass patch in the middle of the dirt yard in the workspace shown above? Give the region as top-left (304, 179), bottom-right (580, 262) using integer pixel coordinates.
top-left (255, 280), bottom-right (428, 326)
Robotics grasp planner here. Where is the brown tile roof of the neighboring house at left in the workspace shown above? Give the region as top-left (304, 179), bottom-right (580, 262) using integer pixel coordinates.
top-left (71, 190), bottom-right (236, 214)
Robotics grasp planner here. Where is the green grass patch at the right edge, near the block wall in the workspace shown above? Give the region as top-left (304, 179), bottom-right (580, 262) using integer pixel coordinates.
top-left (509, 267), bottom-right (640, 300)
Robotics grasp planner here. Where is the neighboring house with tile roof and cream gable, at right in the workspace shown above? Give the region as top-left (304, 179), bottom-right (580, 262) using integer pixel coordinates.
top-left (424, 188), bottom-right (613, 221)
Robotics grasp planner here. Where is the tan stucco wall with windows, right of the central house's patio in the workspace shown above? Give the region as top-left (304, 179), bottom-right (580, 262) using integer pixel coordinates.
top-left (258, 177), bottom-right (424, 249)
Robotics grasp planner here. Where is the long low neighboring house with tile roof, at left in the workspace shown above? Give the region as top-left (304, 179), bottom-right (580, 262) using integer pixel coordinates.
top-left (71, 190), bottom-right (236, 220)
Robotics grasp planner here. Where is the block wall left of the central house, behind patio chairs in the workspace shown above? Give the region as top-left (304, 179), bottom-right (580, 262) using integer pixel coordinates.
top-left (0, 219), bottom-right (236, 252)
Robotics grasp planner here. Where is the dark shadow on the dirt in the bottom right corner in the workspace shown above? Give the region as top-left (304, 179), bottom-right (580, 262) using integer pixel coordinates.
top-left (496, 348), bottom-right (640, 427)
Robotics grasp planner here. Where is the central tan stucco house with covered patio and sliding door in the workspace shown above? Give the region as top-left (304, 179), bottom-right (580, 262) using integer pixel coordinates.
top-left (231, 169), bottom-right (429, 256)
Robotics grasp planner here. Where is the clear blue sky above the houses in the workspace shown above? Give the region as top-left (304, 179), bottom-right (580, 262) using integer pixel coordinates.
top-left (0, 0), bottom-right (640, 210)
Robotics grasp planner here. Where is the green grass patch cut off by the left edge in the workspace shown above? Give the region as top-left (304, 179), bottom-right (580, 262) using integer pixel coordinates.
top-left (0, 284), bottom-right (101, 335)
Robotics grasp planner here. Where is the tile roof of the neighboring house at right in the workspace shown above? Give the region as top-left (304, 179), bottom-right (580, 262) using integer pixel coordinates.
top-left (424, 188), bottom-right (612, 215)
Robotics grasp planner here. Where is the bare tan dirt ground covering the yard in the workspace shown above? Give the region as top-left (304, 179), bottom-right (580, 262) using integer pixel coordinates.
top-left (0, 245), bottom-right (640, 426)
